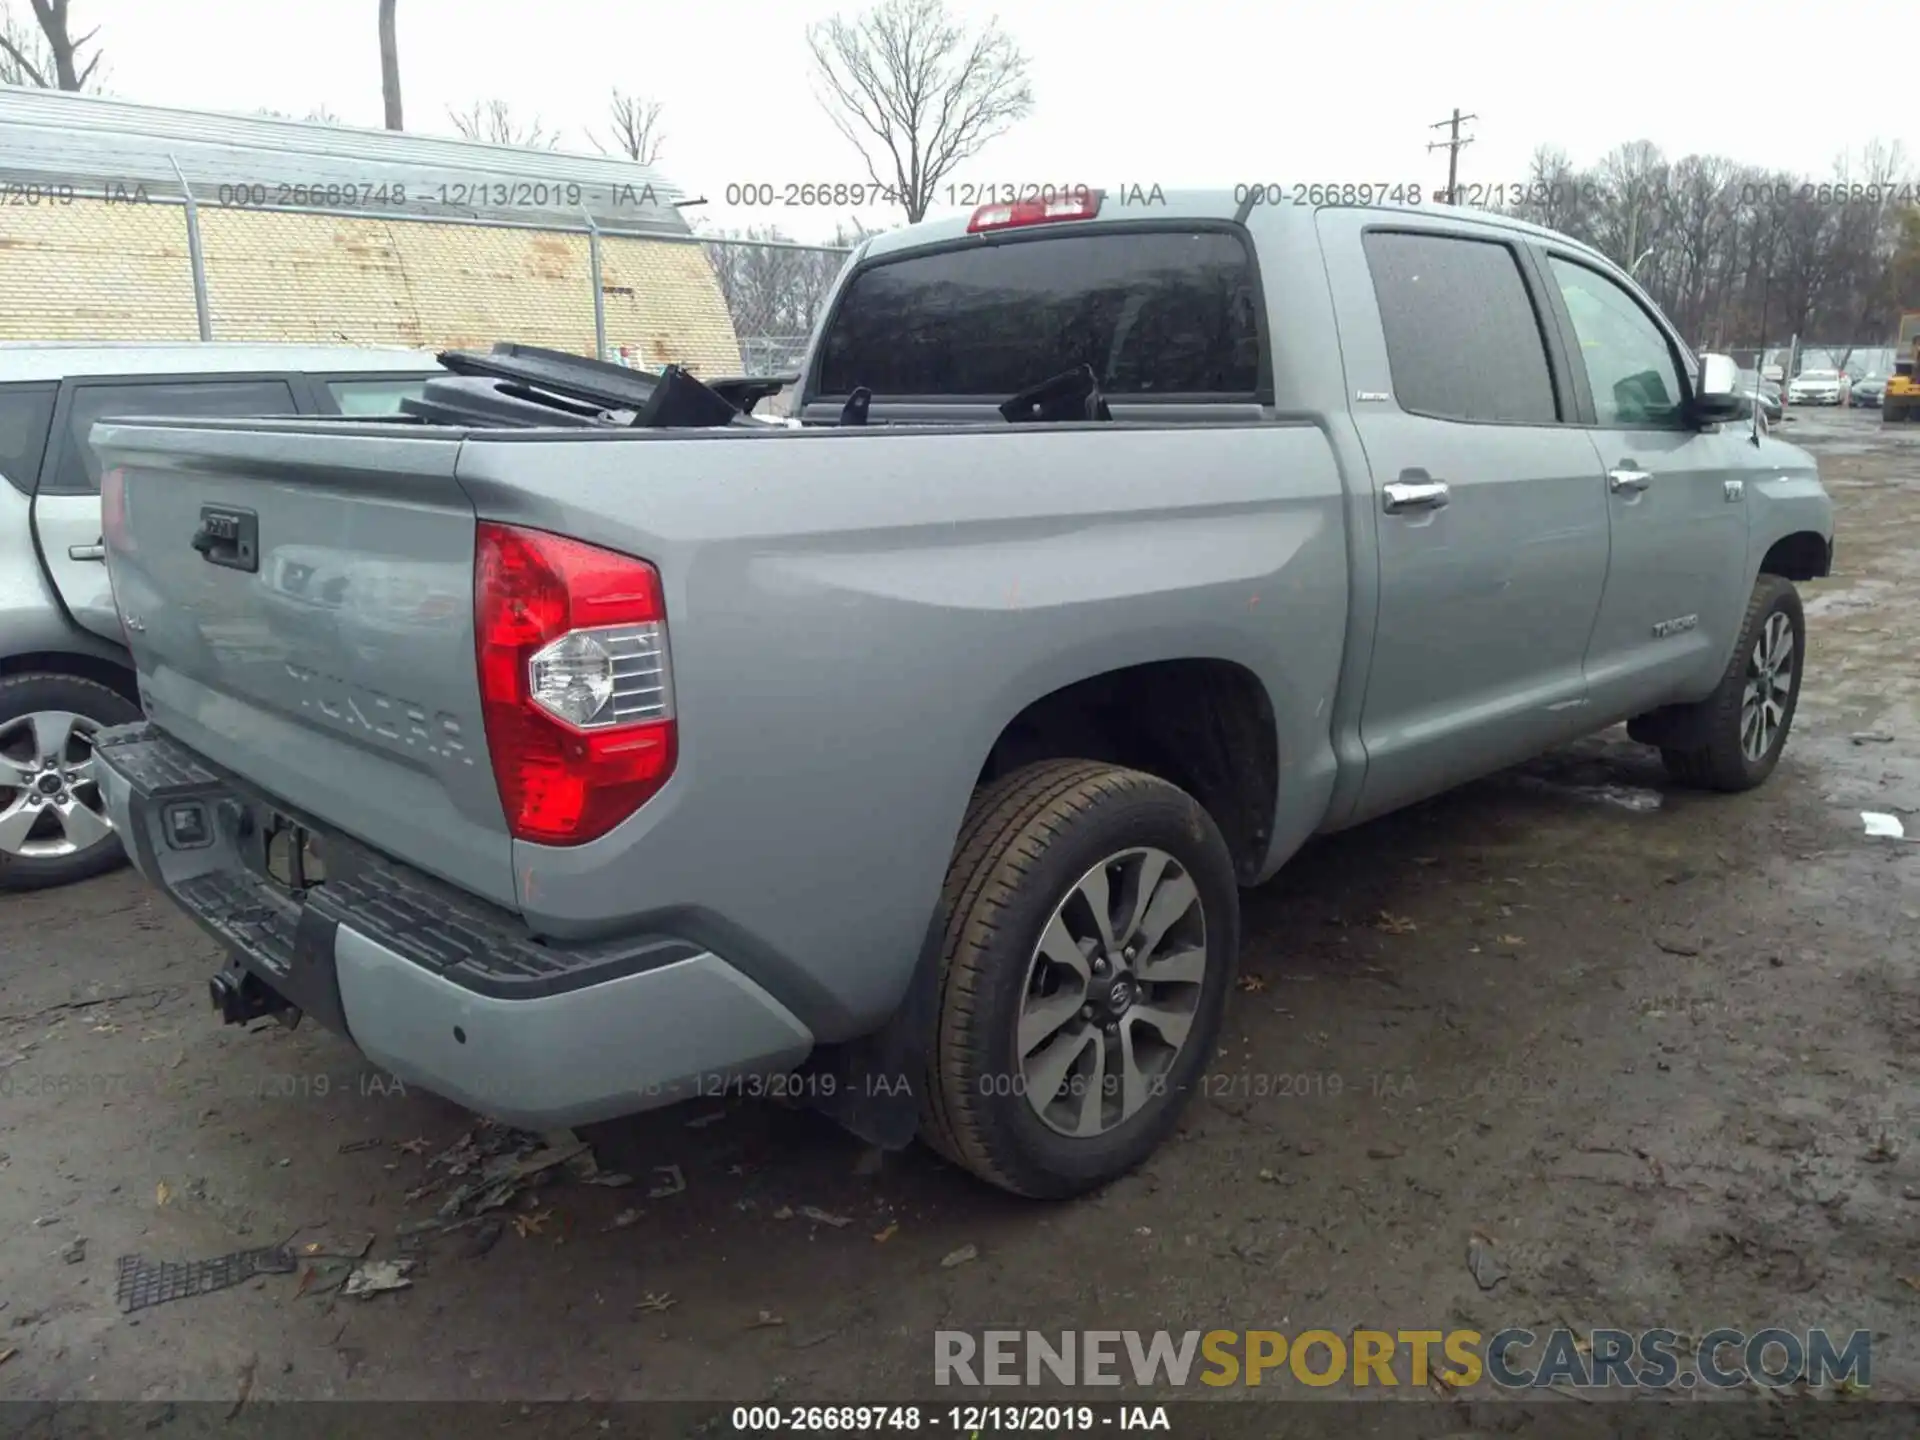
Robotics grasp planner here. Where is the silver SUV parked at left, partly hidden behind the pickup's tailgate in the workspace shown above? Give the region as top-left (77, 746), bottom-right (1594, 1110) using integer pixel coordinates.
top-left (0, 344), bottom-right (438, 889)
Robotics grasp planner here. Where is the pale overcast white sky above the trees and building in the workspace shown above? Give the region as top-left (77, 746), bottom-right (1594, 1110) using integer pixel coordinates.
top-left (63, 0), bottom-right (1914, 238)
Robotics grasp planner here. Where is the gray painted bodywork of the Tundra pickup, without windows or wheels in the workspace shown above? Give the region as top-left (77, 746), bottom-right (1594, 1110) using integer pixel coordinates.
top-left (94, 196), bottom-right (1832, 1117)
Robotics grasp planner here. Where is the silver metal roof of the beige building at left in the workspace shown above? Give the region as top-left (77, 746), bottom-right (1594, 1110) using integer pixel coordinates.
top-left (0, 84), bottom-right (691, 234)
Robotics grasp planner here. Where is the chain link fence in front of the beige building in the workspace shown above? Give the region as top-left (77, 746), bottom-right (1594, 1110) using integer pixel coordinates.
top-left (0, 194), bottom-right (847, 374)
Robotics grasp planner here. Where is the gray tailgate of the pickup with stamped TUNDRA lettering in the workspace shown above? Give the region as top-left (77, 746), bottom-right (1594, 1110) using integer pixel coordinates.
top-left (92, 420), bottom-right (515, 906)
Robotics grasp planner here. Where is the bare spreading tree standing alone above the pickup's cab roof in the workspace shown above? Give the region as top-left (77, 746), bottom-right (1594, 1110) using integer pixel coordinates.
top-left (806, 0), bottom-right (1033, 223)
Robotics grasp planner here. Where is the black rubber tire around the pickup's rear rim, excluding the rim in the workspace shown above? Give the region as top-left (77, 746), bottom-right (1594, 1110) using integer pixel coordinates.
top-left (922, 760), bottom-right (1240, 1198)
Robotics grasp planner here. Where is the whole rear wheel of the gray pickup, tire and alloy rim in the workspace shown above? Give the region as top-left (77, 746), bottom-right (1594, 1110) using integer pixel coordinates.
top-left (922, 760), bottom-right (1240, 1198)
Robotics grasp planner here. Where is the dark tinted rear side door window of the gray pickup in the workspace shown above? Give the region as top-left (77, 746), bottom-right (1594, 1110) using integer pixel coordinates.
top-left (1365, 230), bottom-right (1559, 424)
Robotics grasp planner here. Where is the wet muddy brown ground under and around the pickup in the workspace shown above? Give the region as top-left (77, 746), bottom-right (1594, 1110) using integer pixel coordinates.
top-left (0, 403), bottom-right (1920, 1404)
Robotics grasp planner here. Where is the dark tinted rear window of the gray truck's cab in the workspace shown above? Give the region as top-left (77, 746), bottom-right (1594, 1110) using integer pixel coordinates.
top-left (816, 230), bottom-right (1260, 399)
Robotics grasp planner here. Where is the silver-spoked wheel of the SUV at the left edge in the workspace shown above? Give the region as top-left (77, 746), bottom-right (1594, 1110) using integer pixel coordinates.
top-left (0, 674), bottom-right (140, 891)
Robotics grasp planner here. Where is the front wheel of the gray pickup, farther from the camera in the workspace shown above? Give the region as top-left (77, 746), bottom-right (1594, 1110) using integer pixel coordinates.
top-left (1661, 574), bottom-right (1807, 791)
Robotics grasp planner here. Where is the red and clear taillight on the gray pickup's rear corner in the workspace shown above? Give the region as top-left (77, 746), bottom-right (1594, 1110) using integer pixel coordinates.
top-left (474, 524), bottom-right (676, 845)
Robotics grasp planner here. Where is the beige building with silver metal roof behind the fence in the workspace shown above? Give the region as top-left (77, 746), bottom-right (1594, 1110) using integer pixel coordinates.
top-left (0, 90), bottom-right (741, 374)
